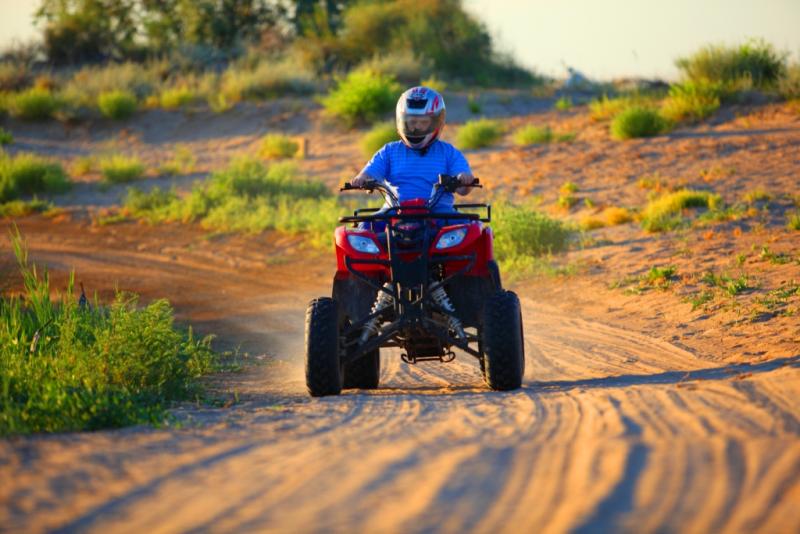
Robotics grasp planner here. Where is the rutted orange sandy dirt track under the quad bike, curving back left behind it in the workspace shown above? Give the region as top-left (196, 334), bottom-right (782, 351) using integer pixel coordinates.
top-left (0, 220), bottom-right (800, 533)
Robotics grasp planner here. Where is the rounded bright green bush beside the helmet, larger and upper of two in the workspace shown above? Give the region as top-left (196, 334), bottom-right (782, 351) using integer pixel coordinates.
top-left (322, 70), bottom-right (400, 126)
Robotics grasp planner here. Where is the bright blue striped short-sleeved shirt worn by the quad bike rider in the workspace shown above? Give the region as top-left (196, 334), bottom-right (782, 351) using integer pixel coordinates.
top-left (361, 140), bottom-right (472, 211)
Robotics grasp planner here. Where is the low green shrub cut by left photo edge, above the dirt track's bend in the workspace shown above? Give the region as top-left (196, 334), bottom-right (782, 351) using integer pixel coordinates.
top-left (0, 153), bottom-right (70, 202)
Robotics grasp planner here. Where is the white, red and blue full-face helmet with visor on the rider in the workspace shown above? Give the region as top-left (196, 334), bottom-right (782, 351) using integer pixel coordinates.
top-left (395, 86), bottom-right (445, 150)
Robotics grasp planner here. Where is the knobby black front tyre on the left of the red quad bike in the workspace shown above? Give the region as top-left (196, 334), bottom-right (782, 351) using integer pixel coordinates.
top-left (306, 297), bottom-right (342, 397)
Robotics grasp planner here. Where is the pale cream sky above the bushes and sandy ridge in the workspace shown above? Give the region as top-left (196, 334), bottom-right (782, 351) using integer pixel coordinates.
top-left (0, 0), bottom-right (800, 80)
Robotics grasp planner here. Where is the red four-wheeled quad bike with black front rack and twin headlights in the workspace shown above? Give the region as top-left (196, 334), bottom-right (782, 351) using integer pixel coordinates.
top-left (305, 175), bottom-right (525, 397)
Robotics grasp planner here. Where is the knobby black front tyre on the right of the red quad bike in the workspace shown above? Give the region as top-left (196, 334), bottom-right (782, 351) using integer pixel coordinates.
top-left (481, 290), bottom-right (525, 391)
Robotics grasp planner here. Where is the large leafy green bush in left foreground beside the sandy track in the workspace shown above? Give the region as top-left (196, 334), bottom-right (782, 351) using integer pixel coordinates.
top-left (0, 235), bottom-right (216, 436)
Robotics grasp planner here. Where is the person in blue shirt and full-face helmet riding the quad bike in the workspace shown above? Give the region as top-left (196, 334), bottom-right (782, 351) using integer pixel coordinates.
top-left (350, 86), bottom-right (475, 212)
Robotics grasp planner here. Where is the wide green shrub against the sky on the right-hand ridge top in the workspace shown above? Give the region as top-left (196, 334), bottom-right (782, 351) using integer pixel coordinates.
top-left (675, 40), bottom-right (786, 88)
